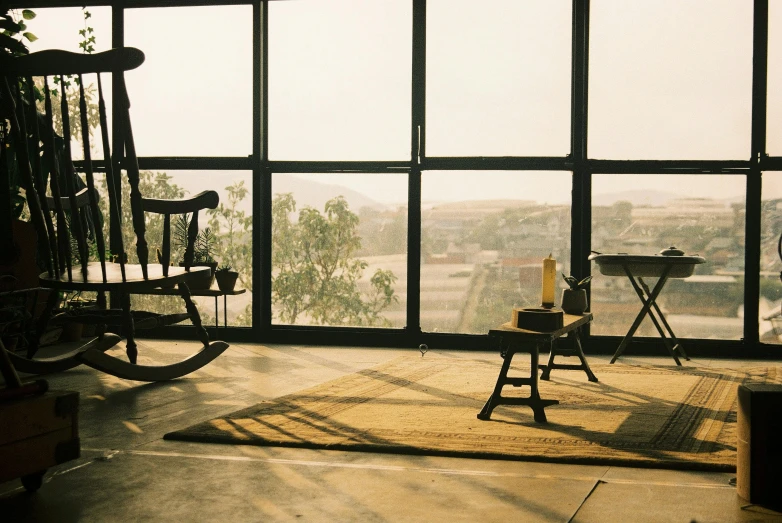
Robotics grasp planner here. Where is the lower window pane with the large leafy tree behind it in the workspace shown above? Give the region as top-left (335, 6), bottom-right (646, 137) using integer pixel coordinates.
top-left (272, 173), bottom-right (407, 328)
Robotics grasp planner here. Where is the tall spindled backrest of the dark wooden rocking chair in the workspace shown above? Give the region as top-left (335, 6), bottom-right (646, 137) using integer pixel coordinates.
top-left (0, 47), bottom-right (148, 282)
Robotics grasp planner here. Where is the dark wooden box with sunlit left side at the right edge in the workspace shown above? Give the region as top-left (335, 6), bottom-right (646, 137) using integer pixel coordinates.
top-left (736, 383), bottom-right (782, 508)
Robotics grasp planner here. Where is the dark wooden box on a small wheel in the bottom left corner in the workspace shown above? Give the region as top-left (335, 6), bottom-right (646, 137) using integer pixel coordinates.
top-left (0, 391), bottom-right (81, 490)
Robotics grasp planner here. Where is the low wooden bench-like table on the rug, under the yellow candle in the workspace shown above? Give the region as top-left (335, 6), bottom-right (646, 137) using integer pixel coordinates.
top-left (478, 313), bottom-right (597, 423)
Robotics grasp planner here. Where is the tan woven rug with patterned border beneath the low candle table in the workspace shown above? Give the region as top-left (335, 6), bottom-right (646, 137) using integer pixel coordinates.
top-left (165, 353), bottom-right (782, 471)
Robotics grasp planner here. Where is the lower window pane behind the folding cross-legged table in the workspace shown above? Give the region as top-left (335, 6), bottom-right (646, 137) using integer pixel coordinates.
top-left (591, 174), bottom-right (746, 339)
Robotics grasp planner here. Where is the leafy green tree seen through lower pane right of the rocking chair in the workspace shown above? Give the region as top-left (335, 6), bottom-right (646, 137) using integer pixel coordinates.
top-left (272, 193), bottom-right (398, 326)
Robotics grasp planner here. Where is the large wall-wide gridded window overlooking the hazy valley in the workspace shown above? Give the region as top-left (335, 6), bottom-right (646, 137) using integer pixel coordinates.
top-left (16, 0), bottom-right (782, 349)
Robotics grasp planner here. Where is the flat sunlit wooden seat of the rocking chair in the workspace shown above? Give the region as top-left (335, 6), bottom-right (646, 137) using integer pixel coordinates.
top-left (39, 262), bottom-right (211, 293)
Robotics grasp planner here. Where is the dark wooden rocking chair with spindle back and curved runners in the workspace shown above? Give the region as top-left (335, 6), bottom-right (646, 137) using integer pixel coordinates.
top-left (0, 47), bottom-right (228, 381)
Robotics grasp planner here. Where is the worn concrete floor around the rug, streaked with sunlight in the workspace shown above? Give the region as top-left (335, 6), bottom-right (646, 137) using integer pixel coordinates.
top-left (0, 341), bottom-right (782, 522)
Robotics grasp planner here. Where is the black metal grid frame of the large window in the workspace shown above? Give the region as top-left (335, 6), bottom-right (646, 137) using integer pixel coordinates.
top-left (11, 0), bottom-right (782, 358)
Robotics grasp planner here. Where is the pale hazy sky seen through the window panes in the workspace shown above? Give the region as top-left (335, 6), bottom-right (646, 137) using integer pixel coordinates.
top-left (16, 0), bottom-right (782, 207)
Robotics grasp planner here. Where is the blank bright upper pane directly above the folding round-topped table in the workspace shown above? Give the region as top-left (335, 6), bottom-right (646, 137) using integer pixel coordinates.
top-left (589, 0), bottom-right (752, 160)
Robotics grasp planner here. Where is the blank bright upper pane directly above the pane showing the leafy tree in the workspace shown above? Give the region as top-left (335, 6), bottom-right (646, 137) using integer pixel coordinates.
top-left (269, 0), bottom-right (412, 160)
